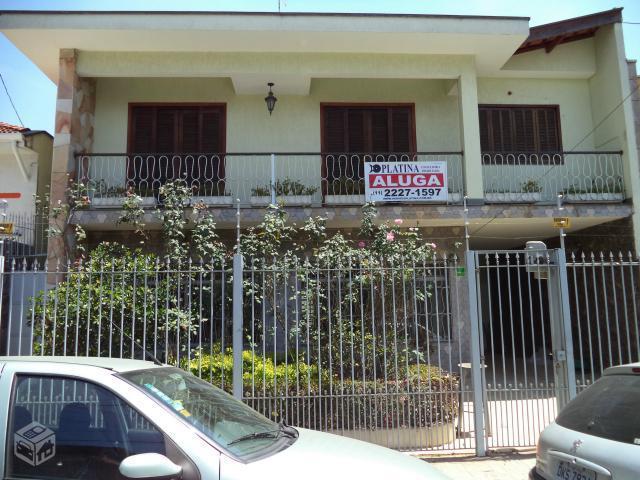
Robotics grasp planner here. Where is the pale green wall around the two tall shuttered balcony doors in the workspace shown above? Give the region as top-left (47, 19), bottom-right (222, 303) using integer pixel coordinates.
top-left (93, 78), bottom-right (461, 201)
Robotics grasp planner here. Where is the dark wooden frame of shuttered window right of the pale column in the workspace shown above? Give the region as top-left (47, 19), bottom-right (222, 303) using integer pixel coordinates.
top-left (478, 103), bottom-right (564, 166)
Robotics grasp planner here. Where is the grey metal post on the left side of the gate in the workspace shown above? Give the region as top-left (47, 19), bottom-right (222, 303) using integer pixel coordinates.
top-left (465, 250), bottom-right (487, 457)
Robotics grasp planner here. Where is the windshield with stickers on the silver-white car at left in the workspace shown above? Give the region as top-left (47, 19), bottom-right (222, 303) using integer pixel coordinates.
top-left (121, 367), bottom-right (294, 460)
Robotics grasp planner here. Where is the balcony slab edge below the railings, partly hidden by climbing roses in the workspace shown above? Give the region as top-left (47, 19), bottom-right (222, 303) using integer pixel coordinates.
top-left (72, 203), bottom-right (633, 248)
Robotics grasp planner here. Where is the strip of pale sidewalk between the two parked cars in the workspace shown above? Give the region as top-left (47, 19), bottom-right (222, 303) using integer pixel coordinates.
top-left (425, 452), bottom-right (536, 480)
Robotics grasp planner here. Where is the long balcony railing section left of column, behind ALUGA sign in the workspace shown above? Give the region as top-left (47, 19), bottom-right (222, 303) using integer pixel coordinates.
top-left (77, 152), bottom-right (464, 207)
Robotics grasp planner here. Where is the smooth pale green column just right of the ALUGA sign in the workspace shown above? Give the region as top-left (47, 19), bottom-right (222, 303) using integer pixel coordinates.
top-left (458, 71), bottom-right (484, 204)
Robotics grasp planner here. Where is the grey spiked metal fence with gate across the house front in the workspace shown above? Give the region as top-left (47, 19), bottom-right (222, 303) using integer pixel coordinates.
top-left (0, 251), bottom-right (640, 453)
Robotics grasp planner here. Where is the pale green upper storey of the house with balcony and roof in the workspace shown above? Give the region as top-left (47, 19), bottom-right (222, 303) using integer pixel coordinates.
top-left (0, 9), bottom-right (640, 256)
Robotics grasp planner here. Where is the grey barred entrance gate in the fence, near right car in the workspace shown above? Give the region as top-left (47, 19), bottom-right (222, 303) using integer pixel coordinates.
top-left (470, 250), bottom-right (576, 452)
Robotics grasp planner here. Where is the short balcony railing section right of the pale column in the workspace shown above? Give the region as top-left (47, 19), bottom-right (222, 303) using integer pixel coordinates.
top-left (482, 151), bottom-right (625, 203)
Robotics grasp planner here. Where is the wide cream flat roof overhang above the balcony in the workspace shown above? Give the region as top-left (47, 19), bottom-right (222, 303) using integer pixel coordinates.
top-left (0, 11), bottom-right (529, 82)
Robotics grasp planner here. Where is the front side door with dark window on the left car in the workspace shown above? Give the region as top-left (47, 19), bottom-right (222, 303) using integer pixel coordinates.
top-left (0, 366), bottom-right (217, 480)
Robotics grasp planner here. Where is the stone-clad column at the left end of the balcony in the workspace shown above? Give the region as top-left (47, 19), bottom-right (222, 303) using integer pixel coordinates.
top-left (48, 49), bottom-right (96, 267)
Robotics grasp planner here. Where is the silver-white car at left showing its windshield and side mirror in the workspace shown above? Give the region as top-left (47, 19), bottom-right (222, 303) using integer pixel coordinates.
top-left (0, 357), bottom-right (445, 480)
